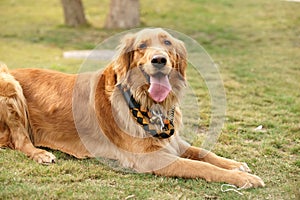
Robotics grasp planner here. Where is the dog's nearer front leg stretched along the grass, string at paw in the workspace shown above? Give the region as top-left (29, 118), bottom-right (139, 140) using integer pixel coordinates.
top-left (154, 158), bottom-right (264, 188)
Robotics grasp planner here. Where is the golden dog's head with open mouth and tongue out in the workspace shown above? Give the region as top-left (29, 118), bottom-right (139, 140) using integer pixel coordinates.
top-left (114, 28), bottom-right (187, 106)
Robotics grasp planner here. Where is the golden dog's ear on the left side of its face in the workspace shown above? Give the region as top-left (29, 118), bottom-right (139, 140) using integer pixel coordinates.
top-left (114, 33), bottom-right (134, 79)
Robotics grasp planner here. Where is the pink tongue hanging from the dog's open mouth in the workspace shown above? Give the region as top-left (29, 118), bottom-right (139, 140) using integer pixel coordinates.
top-left (148, 76), bottom-right (172, 102)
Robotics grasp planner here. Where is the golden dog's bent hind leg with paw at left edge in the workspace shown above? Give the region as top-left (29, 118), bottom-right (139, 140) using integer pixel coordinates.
top-left (0, 63), bottom-right (55, 164)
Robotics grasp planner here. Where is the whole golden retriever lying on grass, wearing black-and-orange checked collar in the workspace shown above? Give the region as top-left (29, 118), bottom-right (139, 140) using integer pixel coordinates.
top-left (0, 29), bottom-right (264, 188)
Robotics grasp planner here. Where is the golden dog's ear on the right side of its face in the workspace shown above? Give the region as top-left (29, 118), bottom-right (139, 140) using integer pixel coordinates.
top-left (175, 40), bottom-right (187, 78)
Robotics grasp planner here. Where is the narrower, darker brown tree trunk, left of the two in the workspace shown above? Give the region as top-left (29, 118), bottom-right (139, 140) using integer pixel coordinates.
top-left (61, 0), bottom-right (87, 27)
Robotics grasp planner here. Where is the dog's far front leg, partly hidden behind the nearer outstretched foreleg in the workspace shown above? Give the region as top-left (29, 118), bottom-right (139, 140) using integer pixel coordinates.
top-left (181, 146), bottom-right (251, 172)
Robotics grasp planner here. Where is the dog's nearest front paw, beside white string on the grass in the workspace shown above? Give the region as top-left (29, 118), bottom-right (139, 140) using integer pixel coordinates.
top-left (232, 171), bottom-right (265, 189)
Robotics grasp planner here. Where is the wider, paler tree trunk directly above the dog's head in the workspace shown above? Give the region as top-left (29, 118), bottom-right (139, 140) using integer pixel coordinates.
top-left (105, 0), bottom-right (140, 29)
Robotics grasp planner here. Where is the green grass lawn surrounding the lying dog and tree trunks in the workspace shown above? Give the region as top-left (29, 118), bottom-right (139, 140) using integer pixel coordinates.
top-left (0, 0), bottom-right (300, 199)
